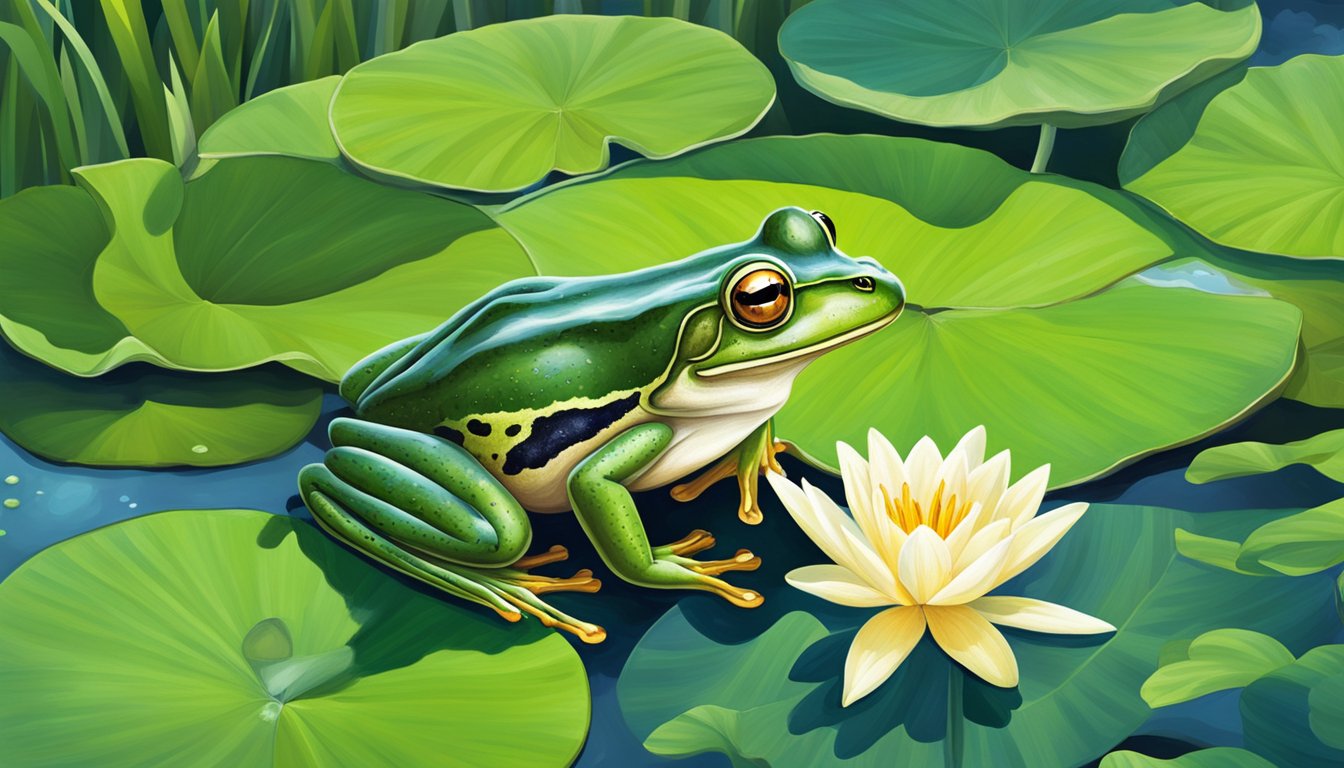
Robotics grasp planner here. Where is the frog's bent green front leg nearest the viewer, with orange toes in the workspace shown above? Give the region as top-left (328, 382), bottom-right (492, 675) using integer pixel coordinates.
top-left (569, 424), bottom-right (762, 608)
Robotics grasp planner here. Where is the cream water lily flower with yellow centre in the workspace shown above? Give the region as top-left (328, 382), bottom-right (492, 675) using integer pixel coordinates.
top-left (767, 426), bottom-right (1116, 706)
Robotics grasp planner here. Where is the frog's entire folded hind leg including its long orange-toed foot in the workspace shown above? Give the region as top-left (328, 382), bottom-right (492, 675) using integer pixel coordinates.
top-left (298, 418), bottom-right (606, 643)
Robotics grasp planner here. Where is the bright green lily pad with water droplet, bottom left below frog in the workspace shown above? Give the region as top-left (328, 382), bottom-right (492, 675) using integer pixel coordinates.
top-left (0, 510), bottom-right (589, 767)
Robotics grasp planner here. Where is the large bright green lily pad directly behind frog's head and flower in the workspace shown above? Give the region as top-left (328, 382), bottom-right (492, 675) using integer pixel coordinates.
top-left (497, 136), bottom-right (1300, 486)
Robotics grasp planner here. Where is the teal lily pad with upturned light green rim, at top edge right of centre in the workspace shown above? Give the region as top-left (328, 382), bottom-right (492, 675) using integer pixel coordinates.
top-left (780, 0), bottom-right (1261, 128)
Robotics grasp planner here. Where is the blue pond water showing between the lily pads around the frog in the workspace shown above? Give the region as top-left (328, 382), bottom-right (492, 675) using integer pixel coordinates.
top-left (0, 395), bottom-right (1344, 767)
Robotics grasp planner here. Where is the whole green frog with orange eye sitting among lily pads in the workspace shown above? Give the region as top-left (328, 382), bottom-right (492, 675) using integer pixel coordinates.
top-left (298, 206), bottom-right (905, 643)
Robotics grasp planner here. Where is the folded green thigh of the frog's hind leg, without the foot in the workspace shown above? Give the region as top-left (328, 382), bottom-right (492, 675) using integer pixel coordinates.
top-left (300, 418), bottom-right (532, 568)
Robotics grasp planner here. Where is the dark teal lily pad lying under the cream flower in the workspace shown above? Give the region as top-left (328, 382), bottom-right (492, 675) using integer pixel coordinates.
top-left (617, 506), bottom-right (1335, 768)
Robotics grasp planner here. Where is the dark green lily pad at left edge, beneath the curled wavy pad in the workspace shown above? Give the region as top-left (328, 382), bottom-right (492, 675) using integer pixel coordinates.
top-left (0, 343), bottom-right (323, 467)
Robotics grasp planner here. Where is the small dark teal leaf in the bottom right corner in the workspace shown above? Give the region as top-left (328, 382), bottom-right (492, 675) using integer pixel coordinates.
top-left (1242, 646), bottom-right (1344, 765)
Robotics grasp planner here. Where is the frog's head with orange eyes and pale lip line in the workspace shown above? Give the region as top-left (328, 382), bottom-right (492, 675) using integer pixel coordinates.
top-left (685, 207), bottom-right (906, 378)
